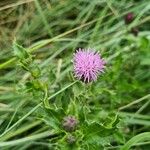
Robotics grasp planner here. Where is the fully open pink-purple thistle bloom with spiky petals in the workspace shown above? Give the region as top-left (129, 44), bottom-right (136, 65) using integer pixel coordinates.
top-left (73, 48), bottom-right (105, 82)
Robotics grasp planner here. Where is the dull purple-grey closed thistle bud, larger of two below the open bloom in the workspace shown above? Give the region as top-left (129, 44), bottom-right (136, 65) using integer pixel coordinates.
top-left (63, 116), bottom-right (79, 132)
